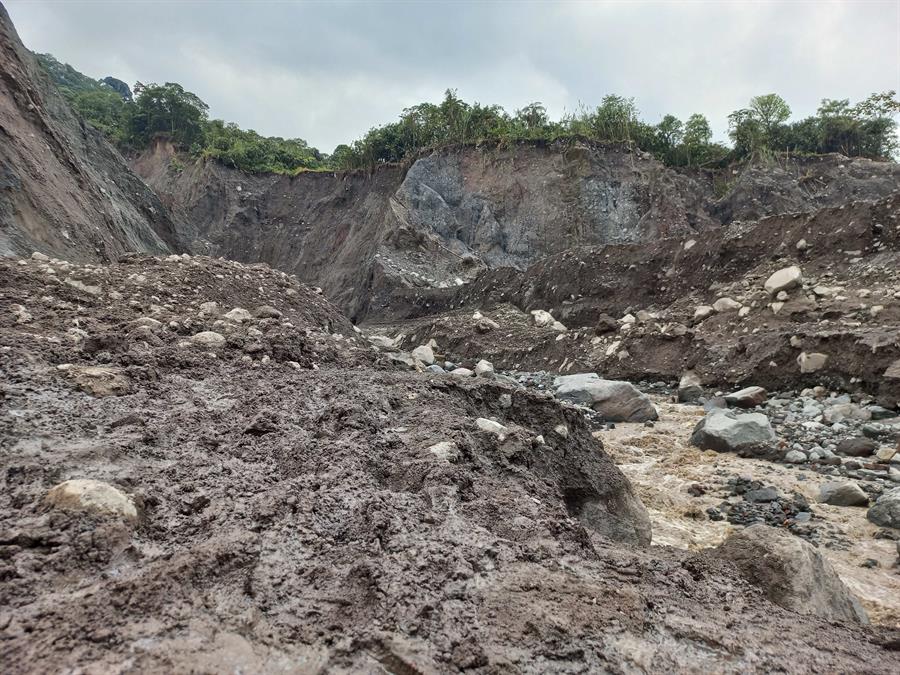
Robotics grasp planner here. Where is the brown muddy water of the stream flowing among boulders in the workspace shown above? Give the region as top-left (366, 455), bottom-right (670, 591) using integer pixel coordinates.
top-left (594, 398), bottom-right (900, 627)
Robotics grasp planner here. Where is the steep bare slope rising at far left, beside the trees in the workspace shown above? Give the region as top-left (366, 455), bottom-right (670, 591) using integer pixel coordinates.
top-left (0, 6), bottom-right (178, 260)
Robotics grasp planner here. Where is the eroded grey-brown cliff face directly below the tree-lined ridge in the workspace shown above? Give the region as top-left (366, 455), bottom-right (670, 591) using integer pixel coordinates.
top-left (132, 143), bottom-right (716, 318)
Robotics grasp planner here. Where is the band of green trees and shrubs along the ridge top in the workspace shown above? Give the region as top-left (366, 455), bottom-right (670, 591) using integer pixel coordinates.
top-left (38, 55), bottom-right (900, 174)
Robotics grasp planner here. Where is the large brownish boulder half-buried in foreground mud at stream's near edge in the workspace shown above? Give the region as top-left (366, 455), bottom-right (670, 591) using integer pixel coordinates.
top-left (716, 524), bottom-right (868, 623)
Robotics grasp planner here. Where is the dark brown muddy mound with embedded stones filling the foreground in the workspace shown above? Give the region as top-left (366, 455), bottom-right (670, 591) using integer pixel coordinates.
top-left (0, 257), bottom-right (900, 672)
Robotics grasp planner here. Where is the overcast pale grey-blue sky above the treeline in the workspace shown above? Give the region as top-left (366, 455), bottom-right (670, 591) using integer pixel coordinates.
top-left (6, 0), bottom-right (900, 152)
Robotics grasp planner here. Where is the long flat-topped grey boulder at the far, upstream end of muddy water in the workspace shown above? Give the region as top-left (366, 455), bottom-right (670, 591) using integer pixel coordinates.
top-left (553, 373), bottom-right (659, 422)
